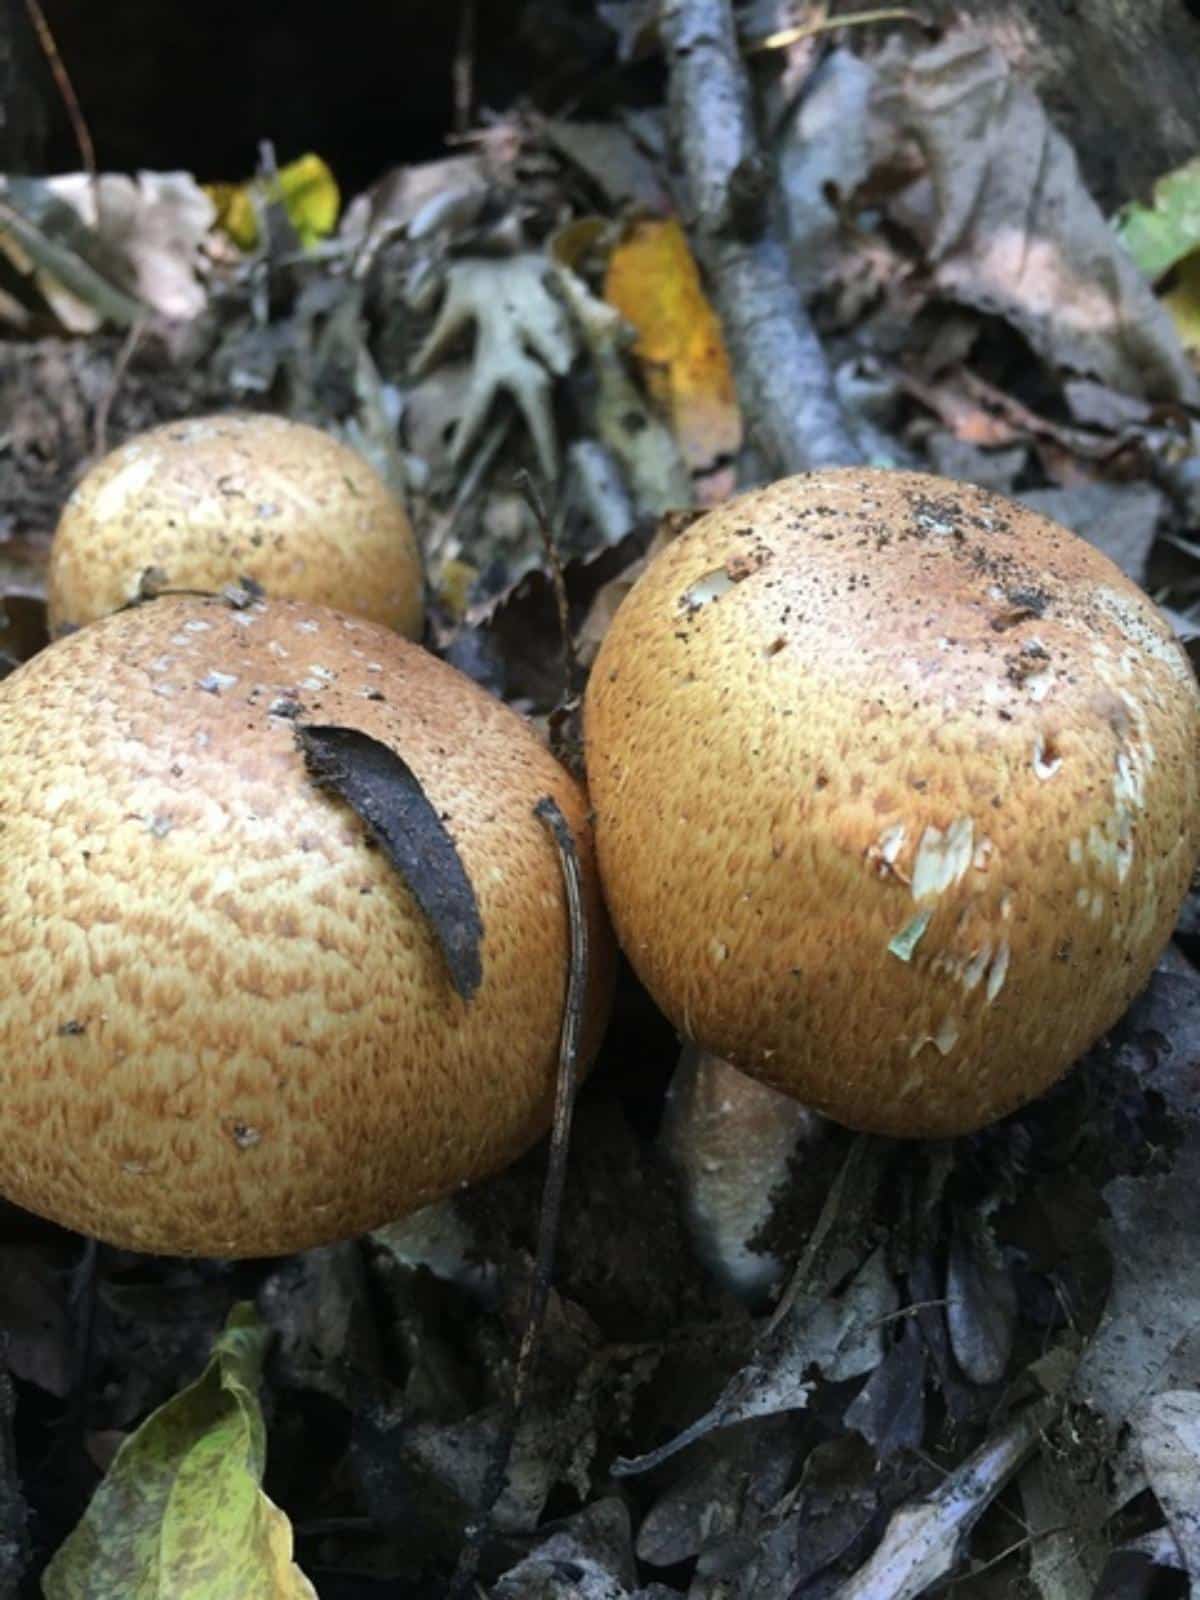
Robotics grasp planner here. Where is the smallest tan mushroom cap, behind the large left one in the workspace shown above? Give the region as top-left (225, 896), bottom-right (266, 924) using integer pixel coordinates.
top-left (46, 413), bottom-right (424, 638)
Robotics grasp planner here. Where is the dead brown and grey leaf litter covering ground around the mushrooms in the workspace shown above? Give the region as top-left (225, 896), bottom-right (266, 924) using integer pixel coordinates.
top-left (0, 5), bottom-right (1200, 1600)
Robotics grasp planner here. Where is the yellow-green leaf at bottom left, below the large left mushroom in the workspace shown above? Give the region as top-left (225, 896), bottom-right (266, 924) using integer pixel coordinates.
top-left (42, 1306), bottom-right (317, 1600)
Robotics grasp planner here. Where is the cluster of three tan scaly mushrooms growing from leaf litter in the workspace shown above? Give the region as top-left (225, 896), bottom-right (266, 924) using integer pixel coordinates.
top-left (0, 454), bottom-right (1200, 1277)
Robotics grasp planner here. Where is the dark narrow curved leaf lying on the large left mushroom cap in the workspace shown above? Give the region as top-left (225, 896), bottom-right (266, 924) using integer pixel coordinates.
top-left (296, 723), bottom-right (483, 1000)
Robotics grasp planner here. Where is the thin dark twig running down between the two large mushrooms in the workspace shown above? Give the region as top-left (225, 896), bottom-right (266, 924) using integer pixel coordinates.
top-left (450, 795), bottom-right (589, 1600)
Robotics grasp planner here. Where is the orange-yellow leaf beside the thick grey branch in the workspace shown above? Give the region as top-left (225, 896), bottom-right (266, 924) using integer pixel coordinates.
top-left (605, 221), bottom-right (742, 469)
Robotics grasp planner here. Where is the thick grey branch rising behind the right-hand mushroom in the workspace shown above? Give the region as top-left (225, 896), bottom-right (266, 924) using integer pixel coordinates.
top-left (659, 0), bottom-right (861, 472)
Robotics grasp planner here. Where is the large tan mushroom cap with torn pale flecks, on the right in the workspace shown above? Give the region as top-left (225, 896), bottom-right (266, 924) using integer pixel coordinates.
top-left (584, 469), bottom-right (1200, 1136)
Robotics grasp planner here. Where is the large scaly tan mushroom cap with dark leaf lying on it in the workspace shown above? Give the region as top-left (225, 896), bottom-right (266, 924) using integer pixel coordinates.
top-left (0, 598), bottom-right (611, 1256)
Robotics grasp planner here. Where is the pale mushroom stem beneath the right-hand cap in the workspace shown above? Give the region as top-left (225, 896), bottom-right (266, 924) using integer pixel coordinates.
top-left (659, 1045), bottom-right (826, 1306)
